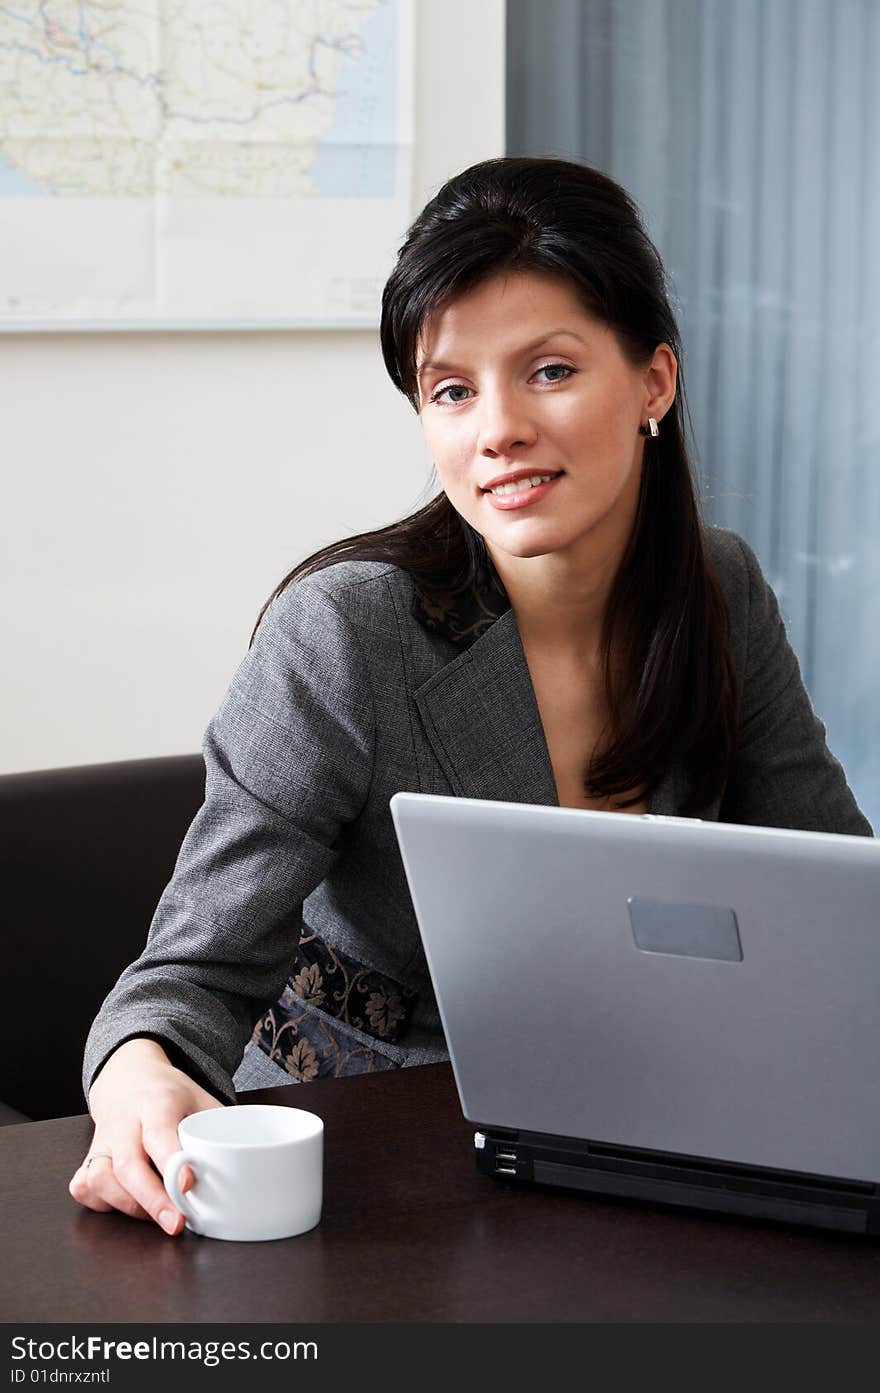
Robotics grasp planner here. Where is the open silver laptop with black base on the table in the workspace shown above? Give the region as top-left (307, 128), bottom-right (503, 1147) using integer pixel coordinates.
top-left (391, 793), bottom-right (880, 1233)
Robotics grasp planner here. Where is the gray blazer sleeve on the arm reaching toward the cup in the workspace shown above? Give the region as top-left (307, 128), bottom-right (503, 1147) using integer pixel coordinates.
top-left (84, 578), bottom-right (375, 1102)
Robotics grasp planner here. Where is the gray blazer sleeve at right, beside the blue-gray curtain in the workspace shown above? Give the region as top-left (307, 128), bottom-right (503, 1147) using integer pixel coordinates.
top-left (720, 538), bottom-right (873, 837)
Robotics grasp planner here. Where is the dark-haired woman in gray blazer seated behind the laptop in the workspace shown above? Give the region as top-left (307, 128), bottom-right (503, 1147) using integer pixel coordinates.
top-left (71, 159), bottom-right (870, 1233)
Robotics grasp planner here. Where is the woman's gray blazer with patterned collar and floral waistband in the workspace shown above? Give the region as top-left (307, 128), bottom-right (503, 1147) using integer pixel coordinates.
top-left (84, 528), bottom-right (872, 1100)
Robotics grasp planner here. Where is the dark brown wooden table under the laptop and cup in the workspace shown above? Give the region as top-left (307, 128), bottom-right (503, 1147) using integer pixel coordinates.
top-left (0, 1064), bottom-right (880, 1322)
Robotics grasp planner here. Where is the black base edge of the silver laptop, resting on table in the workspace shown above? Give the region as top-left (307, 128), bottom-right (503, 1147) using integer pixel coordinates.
top-left (475, 1127), bottom-right (880, 1234)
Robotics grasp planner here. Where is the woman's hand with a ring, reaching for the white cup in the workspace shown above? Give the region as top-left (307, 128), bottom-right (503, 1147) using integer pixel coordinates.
top-left (68, 1039), bottom-right (223, 1234)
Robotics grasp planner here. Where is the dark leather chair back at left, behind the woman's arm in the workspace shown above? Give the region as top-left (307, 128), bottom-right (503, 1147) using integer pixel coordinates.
top-left (0, 755), bottom-right (205, 1124)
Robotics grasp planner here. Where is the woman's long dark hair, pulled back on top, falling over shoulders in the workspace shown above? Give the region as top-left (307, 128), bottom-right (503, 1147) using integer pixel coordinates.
top-left (255, 157), bottom-right (737, 812)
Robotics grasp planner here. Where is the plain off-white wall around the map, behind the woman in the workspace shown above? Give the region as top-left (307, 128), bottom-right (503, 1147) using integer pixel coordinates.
top-left (0, 0), bottom-right (504, 772)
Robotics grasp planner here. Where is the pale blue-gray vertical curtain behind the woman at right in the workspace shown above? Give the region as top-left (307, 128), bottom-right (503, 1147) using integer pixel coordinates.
top-left (507, 0), bottom-right (880, 832)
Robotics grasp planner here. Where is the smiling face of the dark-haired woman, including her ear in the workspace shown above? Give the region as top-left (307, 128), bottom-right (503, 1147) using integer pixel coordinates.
top-left (418, 273), bottom-right (675, 560)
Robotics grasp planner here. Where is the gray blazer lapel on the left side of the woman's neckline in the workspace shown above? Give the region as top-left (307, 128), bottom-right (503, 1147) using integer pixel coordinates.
top-left (415, 609), bottom-right (558, 805)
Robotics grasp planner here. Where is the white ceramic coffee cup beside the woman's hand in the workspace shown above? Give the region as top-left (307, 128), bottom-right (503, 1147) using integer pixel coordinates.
top-left (162, 1103), bottom-right (324, 1243)
